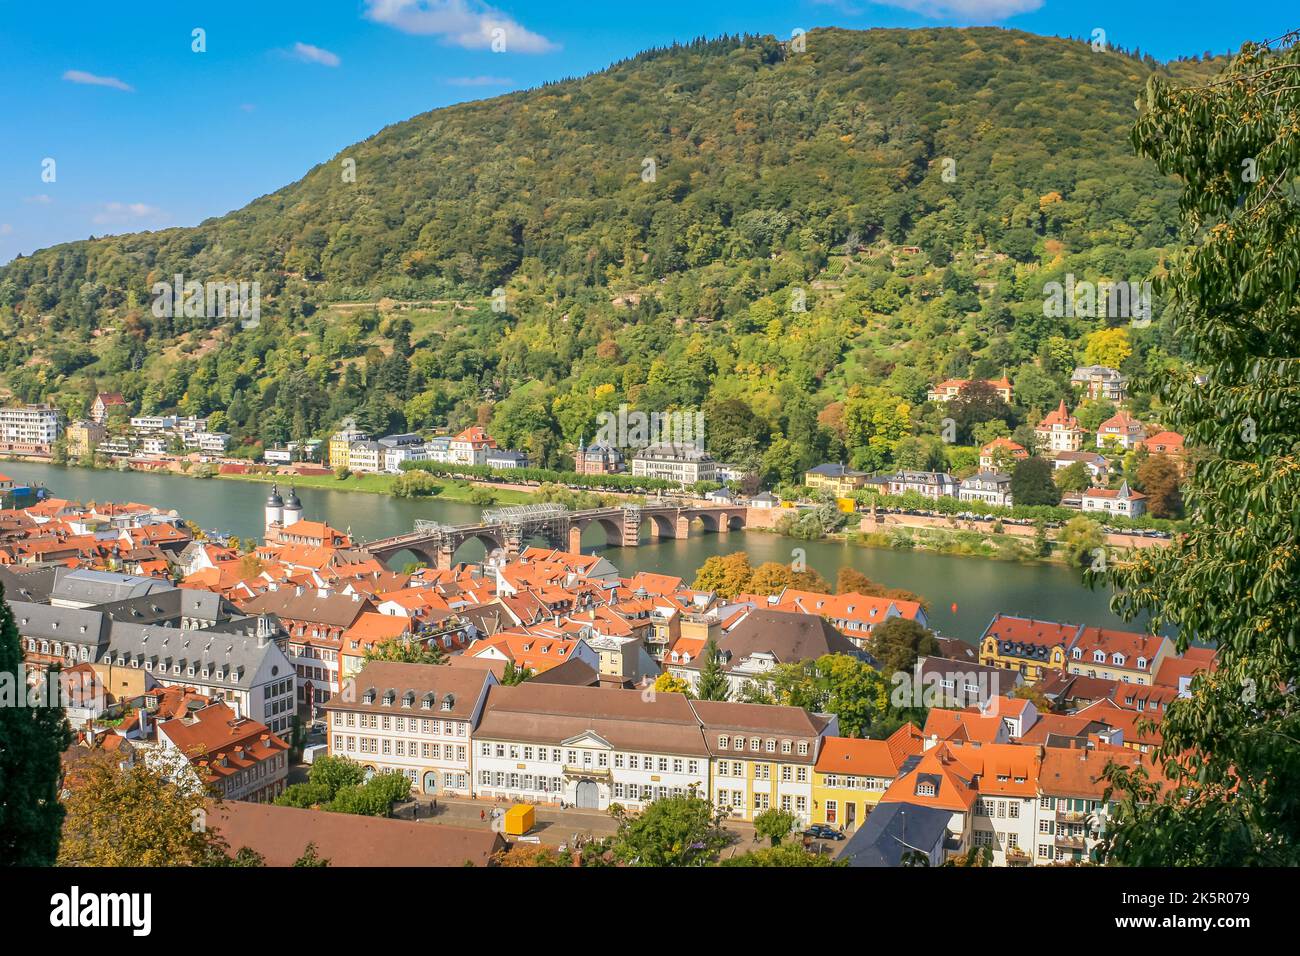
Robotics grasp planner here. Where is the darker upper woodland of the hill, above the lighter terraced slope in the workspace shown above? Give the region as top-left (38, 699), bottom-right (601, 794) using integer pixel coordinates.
top-left (0, 29), bottom-right (1216, 314)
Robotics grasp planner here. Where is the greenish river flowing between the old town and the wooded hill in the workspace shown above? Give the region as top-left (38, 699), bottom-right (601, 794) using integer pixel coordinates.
top-left (0, 462), bottom-right (1138, 641)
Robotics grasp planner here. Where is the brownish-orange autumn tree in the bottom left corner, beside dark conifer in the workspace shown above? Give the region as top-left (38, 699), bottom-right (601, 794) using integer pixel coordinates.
top-left (59, 750), bottom-right (226, 866)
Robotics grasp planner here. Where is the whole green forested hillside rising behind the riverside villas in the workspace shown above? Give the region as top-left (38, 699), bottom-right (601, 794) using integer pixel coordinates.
top-left (0, 29), bottom-right (1219, 483)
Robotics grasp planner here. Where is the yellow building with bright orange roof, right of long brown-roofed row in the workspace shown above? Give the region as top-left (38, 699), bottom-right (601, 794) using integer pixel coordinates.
top-left (810, 723), bottom-right (923, 832)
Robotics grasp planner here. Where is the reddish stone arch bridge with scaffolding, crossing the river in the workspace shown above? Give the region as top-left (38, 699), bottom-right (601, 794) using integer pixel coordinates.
top-left (361, 501), bottom-right (749, 570)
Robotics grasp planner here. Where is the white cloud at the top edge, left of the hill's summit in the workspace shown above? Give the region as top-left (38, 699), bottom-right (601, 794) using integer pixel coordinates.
top-left (365, 0), bottom-right (559, 53)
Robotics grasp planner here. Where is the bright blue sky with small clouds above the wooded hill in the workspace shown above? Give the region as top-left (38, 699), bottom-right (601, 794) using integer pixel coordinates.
top-left (0, 0), bottom-right (1297, 263)
